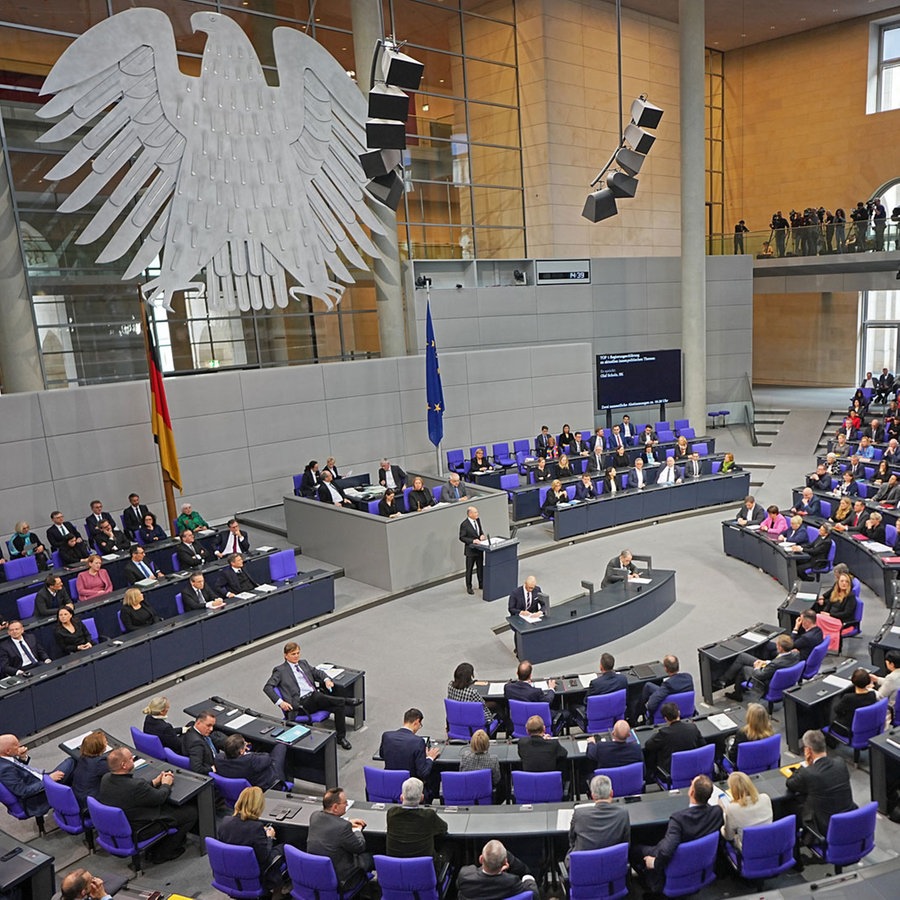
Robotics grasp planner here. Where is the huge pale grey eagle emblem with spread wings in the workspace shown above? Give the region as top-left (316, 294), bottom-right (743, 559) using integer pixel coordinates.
top-left (38, 9), bottom-right (384, 310)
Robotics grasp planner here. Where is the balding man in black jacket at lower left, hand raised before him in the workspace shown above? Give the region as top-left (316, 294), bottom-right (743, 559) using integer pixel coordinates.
top-left (97, 747), bottom-right (197, 862)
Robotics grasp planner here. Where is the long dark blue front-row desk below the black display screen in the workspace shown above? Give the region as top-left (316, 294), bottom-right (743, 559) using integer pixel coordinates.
top-left (553, 472), bottom-right (750, 541)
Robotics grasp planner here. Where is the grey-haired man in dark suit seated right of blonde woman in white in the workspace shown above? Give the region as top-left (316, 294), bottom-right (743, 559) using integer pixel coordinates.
top-left (785, 731), bottom-right (856, 844)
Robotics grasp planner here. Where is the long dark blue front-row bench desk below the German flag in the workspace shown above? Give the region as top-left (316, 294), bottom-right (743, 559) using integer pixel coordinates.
top-left (0, 559), bottom-right (334, 735)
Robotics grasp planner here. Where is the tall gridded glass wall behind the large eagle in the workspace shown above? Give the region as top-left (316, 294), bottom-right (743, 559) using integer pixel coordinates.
top-left (0, 0), bottom-right (525, 387)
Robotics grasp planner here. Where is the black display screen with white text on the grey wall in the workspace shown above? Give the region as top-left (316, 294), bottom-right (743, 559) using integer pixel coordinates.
top-left (597, 350), bottom-right (681, 409)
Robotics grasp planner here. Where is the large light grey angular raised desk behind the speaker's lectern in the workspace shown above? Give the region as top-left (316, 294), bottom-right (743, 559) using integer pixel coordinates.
top-left (284, 473), bottom-right (509, 593)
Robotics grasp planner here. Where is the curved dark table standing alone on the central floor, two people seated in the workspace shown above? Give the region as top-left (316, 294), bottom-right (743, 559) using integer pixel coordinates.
top-left (507, 569), bottom-right (675, 662)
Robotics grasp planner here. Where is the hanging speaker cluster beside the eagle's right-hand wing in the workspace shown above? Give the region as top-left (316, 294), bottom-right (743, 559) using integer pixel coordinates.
top-left (359, 39), bottom-right (425, 211)
